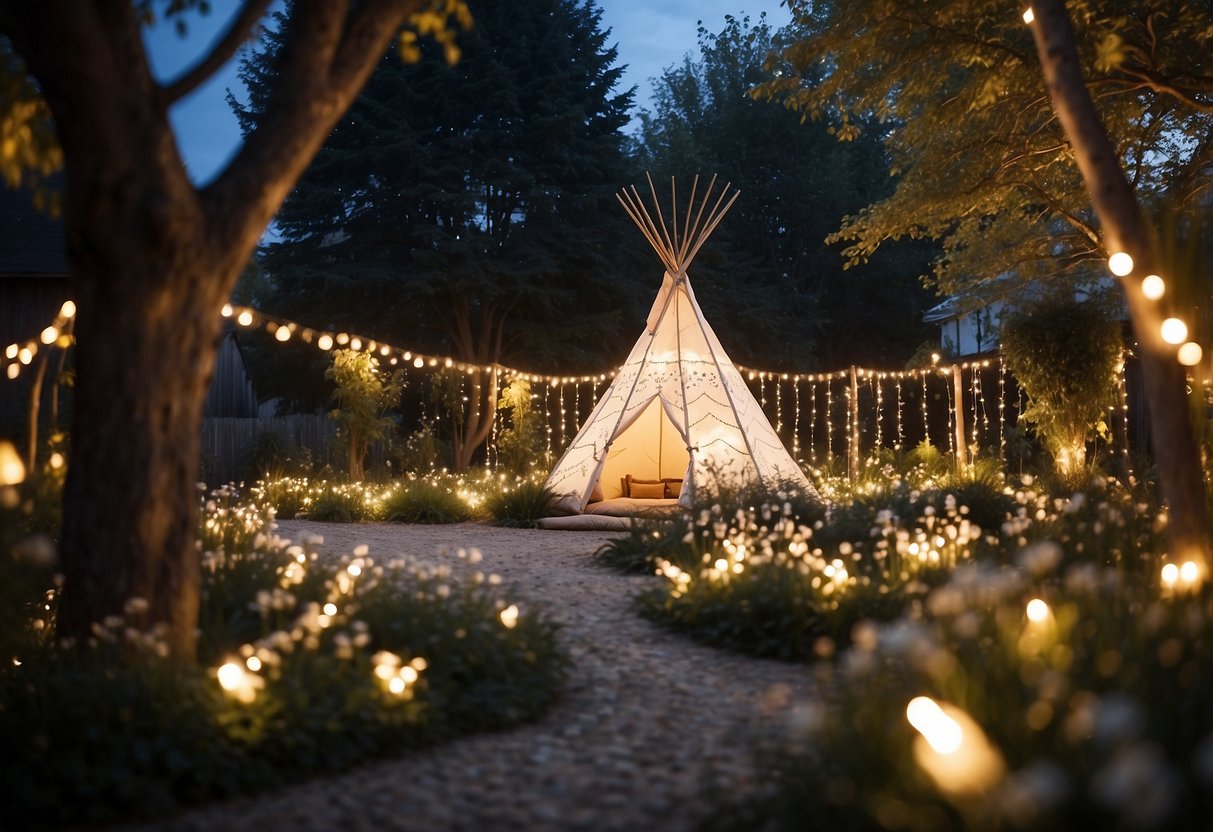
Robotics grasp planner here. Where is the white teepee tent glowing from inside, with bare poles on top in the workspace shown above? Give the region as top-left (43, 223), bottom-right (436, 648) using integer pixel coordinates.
top-left (547, 176), bottom-right (813, 513)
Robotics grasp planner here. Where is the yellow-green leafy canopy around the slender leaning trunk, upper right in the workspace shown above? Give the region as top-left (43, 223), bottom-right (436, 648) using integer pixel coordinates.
top-left (759, 0), bottom-right (1213, 309)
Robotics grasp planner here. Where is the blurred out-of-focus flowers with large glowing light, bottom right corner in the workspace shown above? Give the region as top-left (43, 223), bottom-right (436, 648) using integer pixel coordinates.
top-left (718, 553), bottom-right (1213, 830)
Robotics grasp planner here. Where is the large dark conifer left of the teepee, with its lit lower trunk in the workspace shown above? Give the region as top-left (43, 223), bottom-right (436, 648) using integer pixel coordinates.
top-left (231, 0), bottom-right (638, 467)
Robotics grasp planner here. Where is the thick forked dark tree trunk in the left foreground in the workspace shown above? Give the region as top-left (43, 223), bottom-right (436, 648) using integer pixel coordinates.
top-left (0, 0), bottom-right (420, 661)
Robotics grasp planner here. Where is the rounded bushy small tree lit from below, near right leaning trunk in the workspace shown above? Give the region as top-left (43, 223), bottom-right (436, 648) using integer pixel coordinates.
top-left (1002, 296), bottom-right (1121, 477)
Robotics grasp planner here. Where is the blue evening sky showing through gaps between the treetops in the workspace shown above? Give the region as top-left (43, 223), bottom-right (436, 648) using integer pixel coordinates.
top-left (146, 0), bottom-right (790, 182)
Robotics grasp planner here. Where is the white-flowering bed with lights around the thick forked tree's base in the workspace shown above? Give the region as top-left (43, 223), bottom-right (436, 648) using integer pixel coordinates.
top-left (0, 490), bottom-right (566, 828)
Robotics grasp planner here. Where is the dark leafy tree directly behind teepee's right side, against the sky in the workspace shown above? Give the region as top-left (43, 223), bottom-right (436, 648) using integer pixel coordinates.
top-left (637, 16), bottom-right (934, 369)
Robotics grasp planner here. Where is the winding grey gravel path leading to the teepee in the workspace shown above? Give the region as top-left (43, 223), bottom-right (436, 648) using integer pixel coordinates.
top-left (130, 520), bottom-right (813, 832)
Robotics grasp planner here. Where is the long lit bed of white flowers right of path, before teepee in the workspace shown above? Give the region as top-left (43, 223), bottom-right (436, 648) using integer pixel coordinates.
top-left (630, 478), bottom-right (1159, 660)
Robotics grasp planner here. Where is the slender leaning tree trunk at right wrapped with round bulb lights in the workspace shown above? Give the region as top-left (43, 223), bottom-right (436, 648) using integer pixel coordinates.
top-left (1032, 0), bottom-right (1209, 565)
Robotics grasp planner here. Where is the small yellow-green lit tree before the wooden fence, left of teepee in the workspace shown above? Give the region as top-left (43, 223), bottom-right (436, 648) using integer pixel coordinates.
top-left (324, 349), bottom-right (404, 481)
